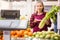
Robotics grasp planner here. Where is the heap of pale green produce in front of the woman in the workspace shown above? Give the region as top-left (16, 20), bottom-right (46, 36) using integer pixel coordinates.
top-left (32, 31), bottom-right (60, 40)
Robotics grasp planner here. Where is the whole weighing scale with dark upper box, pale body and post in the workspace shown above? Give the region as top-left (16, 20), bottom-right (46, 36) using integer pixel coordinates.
top-left (0, 10), bottom-right (28, 40)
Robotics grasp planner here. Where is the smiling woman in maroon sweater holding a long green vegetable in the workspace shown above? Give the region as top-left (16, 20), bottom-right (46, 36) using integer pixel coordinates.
top-left (30, 2), bottom-right (51, 32)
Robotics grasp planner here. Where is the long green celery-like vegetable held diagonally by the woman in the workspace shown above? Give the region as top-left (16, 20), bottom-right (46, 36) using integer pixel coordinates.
top-left (39, 6), bottom-right (60, 28)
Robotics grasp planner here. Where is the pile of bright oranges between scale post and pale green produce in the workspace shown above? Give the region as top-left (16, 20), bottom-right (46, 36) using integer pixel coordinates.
top-left (11, 28), bottom-right (33, 38)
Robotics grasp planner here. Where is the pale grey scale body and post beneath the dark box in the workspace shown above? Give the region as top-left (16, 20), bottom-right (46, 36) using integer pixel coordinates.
top-left (0, 20), bottom-right (27, 40)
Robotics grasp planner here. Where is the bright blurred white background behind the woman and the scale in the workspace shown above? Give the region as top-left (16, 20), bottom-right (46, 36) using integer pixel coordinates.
top-left (0, 0), bottom-right (59, 28)
